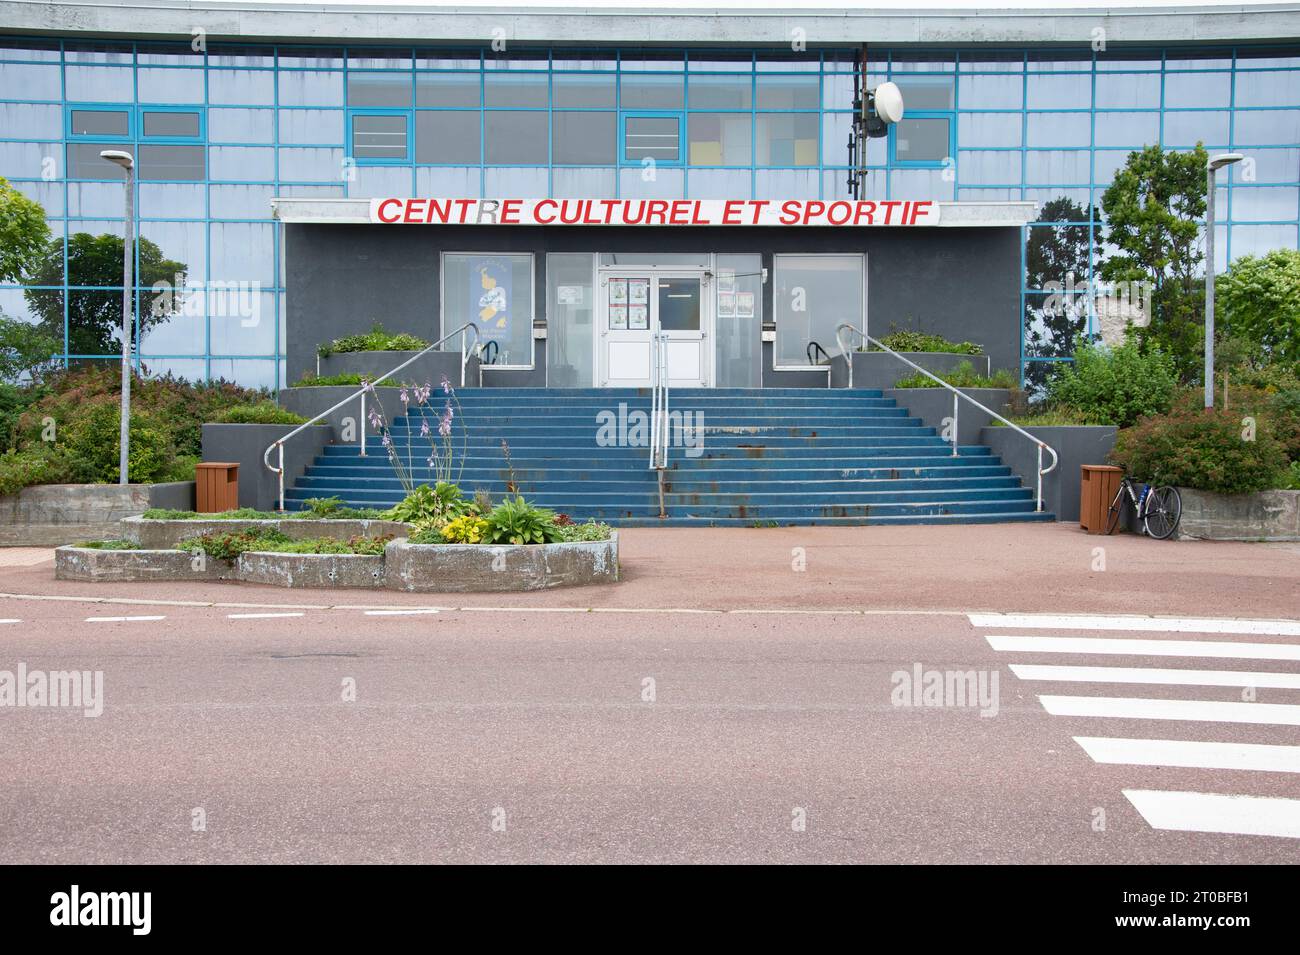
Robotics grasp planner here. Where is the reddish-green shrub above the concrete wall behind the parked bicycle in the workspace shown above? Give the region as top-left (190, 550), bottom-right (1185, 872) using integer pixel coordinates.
top-left (1110, 407), bottom-right (1287, 494)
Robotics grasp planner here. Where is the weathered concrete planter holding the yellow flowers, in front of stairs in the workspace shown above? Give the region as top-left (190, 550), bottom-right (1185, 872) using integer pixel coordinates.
top-left (385, 533), bottom-right (619, 594)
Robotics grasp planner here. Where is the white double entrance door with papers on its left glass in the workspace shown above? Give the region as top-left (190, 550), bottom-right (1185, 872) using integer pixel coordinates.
top-left (597, 269), bottom-right (712, 388)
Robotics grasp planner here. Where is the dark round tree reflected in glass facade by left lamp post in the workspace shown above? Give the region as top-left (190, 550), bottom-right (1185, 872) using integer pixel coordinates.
top-left (23, 233), bottom-right (189, 355)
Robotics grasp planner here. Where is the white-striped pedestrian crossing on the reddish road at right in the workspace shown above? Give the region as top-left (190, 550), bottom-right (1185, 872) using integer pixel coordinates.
top-left (969, 613), bottom-right (1300, 838)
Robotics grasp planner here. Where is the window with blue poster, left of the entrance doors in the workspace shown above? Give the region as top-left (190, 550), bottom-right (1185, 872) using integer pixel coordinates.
top-left (442, 253), bottom-right (533, 365)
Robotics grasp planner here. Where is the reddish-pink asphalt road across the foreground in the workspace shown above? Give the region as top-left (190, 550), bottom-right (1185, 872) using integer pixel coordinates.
top-left (0, 574), bottom-right (1300, 863)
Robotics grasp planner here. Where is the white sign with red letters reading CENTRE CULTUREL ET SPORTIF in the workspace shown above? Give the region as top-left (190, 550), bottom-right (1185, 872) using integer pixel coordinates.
top-left (371, 199), bottom-right (939, 227)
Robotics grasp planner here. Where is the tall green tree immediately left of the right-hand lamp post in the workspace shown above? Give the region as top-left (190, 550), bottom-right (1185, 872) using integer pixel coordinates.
top-left (1099, 143), bottom-right (1209, 382)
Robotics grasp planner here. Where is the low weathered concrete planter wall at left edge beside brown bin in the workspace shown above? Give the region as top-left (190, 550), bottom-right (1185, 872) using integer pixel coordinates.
top-left (0, 481), bottom-right (194, 547)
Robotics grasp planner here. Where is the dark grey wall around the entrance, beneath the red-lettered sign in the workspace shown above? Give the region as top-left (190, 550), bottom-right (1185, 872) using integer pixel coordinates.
top-left (285, 223), bottom-right (1021, 385)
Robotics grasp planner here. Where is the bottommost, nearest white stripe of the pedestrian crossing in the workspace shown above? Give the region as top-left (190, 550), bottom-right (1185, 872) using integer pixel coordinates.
top-left (1123, 789), bottom-right (1300, 839)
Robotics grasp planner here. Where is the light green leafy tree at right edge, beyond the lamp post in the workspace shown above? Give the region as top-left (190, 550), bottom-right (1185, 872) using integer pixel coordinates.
top-left (1214, 248), bottom-right (1300, 366)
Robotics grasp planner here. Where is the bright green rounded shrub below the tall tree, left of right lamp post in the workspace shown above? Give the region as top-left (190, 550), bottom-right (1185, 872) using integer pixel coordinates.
top-left (1048, 340), bottom-right (1178, 427)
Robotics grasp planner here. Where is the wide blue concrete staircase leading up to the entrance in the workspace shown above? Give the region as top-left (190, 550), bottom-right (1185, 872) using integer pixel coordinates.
top-left (286, 388), bottom-right (1054, 526)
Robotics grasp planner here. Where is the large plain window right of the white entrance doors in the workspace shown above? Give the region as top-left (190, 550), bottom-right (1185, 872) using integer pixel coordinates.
top-left (772, 255), bottom-right (865, 365)
